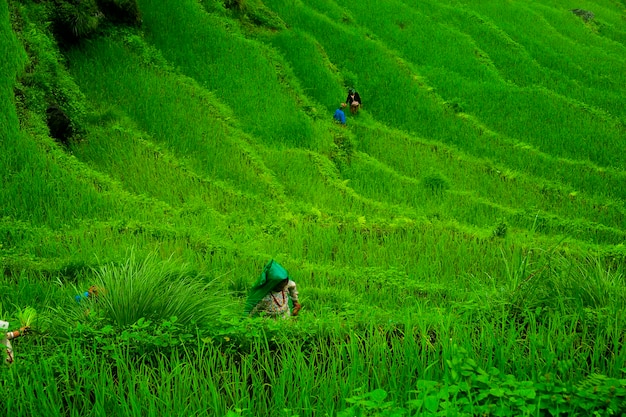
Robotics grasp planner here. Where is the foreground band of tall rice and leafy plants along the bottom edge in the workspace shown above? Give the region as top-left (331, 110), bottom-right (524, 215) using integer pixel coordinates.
top-left (0, 329), bottom-right (626, 416)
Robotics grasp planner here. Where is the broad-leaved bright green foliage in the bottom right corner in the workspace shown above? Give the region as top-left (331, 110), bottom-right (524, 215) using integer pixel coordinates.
top-left (407, 344), bottom-right (626, 416)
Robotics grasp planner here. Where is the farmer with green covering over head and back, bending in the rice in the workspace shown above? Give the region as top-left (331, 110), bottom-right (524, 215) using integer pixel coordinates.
top-left (244, 260), bottom-right (300, 319)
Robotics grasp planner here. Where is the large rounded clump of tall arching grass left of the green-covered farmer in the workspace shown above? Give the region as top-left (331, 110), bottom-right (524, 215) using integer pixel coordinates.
top-left (88, 249), bottom-right (223, 326)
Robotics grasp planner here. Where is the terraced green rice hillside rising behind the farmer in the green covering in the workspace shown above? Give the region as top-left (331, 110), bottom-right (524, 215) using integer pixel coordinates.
top-left (2, 0), bottom-right (626, 278)
